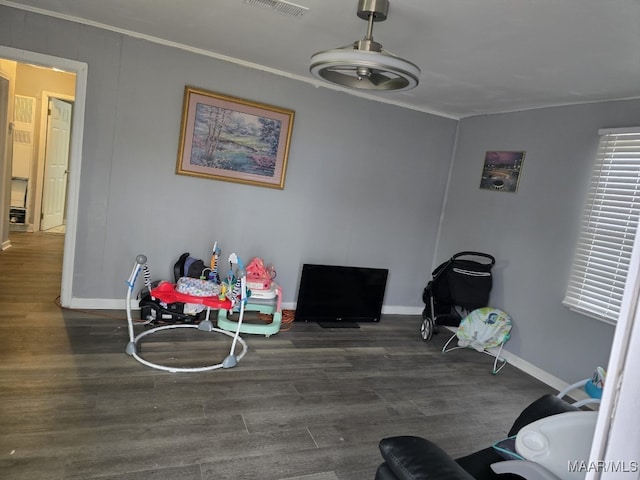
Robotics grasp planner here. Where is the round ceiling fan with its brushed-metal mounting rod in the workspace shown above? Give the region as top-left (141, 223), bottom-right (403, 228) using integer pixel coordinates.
top-left (309, 0), bottom-right (420, 91)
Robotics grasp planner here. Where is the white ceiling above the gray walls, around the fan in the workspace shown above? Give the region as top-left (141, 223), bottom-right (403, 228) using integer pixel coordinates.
top-left (5, 0), bottom-right (640, 118)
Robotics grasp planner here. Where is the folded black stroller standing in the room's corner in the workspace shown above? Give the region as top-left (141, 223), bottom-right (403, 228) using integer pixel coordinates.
top-left (420, 252), bottom-right (496, 342)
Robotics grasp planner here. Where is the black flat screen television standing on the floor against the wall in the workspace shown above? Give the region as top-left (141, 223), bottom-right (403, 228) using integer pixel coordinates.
top-left (295, 263), bottom-right (389, 326)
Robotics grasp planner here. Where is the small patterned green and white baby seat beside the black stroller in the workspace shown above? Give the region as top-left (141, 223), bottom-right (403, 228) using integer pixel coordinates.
top-left (442, 307), bottom-right (511, 375)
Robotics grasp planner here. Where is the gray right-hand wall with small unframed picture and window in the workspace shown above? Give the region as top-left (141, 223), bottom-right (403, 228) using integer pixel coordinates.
top-left (435, 101), bottom-right (640, 381)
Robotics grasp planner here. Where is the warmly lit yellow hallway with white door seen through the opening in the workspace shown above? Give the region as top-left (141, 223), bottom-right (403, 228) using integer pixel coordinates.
top-left (5, 65), bottom-right (76, 233)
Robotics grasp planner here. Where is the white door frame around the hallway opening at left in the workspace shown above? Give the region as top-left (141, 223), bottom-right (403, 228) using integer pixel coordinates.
top-left (0, 45), bottom-right (88, 307)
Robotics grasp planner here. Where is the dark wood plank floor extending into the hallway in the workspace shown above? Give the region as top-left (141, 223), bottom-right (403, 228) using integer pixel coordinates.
top-left (0, 233), bottom-right (555, 480)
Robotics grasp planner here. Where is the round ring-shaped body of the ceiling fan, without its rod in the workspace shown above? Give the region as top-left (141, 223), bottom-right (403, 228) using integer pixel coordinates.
top-left (309, 48), bottom-right (420, 92)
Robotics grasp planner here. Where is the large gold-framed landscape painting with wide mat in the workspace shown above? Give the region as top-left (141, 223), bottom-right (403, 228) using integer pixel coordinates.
top-left (176, 87), bottom-right (294, 189)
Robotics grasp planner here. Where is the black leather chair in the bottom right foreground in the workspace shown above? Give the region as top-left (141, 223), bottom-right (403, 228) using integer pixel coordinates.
top-left (375, 394), bottom-right (579, 480)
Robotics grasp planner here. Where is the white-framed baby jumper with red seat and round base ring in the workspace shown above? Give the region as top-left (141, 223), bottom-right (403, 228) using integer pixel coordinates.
top-left (125, 246), bottom-right (247, 373)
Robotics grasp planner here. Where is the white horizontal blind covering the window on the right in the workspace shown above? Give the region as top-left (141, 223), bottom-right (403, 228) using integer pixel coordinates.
top-left (563, 127), bottom-right (640, 324)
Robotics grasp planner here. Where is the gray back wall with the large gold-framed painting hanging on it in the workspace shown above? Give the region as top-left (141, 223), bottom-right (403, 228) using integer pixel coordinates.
top-left (0, 7), bottom-right (457, 308)
